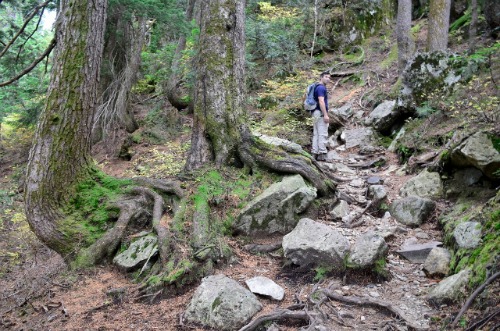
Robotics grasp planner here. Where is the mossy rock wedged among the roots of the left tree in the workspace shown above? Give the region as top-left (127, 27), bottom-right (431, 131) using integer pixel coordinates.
top-left (113, 234), bottom-right (158, 271)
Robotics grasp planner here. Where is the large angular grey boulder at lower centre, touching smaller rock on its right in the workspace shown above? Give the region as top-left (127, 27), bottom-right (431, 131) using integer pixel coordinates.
top-left (283, 218), bottom-right (349, 270)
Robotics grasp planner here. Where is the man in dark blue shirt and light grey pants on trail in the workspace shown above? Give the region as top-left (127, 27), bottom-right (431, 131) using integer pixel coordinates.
top-left (311, 71), bottom-right (330, 161)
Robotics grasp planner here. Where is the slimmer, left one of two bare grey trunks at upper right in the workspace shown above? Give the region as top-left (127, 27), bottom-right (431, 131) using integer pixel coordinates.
top-left (396, 0), bottom-right (414, 74)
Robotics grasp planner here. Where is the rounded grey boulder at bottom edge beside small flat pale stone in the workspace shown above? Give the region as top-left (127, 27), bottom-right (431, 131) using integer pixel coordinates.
top-left (184, 275), bottom-right (262, 331)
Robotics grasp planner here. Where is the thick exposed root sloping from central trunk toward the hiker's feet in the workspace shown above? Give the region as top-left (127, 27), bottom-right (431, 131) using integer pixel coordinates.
top-left (238, 129), bottom-right (335, 196)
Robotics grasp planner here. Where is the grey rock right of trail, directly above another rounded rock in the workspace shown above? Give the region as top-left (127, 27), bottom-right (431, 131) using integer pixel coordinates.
top-left (399, 169), bottom-right (443, 198)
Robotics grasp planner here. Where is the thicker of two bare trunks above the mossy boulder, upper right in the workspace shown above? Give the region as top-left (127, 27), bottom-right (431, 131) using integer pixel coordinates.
top-left (427, 0), bottom-right (451, 52)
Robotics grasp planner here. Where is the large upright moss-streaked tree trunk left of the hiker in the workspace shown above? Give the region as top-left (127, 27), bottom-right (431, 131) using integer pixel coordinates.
top-left (186, 0), bottom-right (245, 170)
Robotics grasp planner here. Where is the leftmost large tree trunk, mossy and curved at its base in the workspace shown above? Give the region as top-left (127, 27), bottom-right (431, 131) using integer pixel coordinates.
top-left (25, 0), bottom-right (107, 254)
